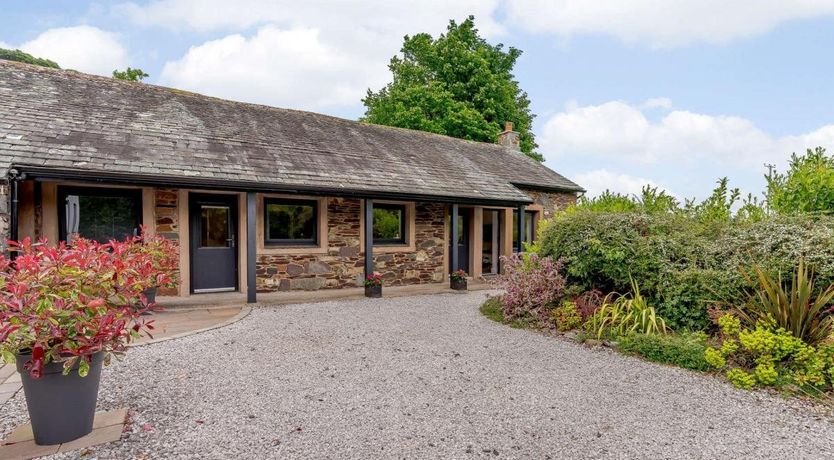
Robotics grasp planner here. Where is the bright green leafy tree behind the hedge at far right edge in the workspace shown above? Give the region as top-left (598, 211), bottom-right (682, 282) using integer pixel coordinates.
top-left (765, 147), bottom-right (834, 214)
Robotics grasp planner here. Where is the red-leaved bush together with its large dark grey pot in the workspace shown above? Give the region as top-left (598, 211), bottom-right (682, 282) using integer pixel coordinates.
top-left (0, 238), bottom-right (169, 445)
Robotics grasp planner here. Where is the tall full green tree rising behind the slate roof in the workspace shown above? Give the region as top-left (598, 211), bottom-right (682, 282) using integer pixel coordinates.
top-left (362, 16), bottom-right (543, 161)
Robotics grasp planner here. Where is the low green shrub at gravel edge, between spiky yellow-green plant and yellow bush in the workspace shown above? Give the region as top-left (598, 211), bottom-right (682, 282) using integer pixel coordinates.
top-left (619, 332), bottom-right (710, 371)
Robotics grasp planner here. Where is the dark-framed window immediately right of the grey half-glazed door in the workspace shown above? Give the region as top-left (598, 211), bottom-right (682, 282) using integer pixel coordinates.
top-left (264, 198), bottom-right (318, 245)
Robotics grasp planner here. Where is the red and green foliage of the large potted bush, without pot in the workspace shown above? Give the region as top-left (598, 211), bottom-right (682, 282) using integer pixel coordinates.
top-left (0, 237), bottom-right (173, 378)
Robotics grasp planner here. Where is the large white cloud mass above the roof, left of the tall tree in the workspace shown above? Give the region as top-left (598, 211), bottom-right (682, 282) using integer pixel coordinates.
top-left (116, 0), bottom-right (502, 111)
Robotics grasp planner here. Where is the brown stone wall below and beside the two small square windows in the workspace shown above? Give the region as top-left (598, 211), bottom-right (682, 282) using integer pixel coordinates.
top-left (256, 198), bottom-right (446, 292)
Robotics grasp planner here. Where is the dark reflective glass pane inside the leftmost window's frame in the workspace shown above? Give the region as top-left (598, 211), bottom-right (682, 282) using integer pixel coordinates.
top-left (66, 195), bottom-right (138, 243)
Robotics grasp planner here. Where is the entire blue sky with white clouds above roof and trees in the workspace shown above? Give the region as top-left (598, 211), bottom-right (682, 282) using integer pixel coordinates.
top-left (0, 0), bottom-right (834, 199)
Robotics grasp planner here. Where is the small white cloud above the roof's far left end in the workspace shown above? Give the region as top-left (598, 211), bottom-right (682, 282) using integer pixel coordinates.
top-left (16, 26), bottom-right (128, 76)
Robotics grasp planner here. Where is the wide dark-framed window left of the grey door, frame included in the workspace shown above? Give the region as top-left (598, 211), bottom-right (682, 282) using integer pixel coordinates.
top-left (58, 187), bottom-right (142, 243)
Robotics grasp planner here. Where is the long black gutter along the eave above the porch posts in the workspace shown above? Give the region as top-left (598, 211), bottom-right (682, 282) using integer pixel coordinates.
top-left (10, 164), bottom-right (533, 208)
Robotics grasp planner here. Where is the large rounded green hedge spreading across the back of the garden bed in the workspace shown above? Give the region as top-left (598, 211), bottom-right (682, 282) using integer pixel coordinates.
top-left (539, 210), bottom-right (834, 330)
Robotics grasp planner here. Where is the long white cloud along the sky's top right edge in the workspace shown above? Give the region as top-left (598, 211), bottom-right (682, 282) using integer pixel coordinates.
top-left (507, 0), bottom-right (834, 48)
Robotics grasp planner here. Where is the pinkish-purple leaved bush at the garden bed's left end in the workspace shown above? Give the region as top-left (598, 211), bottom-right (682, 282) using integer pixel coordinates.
top-left (497, 253), bottom-right (565, 323)
